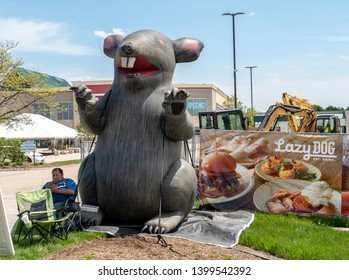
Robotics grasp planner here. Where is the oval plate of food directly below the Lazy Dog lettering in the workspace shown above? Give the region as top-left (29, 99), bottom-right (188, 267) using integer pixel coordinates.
top-left (255, 155), bottom-right (321, 182)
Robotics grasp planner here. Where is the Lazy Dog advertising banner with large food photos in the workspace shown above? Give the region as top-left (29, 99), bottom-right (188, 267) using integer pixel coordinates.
top-left (199, 130), bottom-right (349, 217)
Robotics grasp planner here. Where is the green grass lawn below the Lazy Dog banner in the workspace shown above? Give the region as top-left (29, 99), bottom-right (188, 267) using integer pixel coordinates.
top-left (239, 213), bottom-right (349, 260)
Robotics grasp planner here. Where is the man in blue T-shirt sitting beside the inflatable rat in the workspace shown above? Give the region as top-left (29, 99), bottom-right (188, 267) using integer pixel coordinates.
top-left (42, 168), bottom-right (77, 209)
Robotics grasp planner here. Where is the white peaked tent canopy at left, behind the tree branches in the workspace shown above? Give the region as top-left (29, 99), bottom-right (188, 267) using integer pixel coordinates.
top-left (0, 113), bottom-right (78, 139)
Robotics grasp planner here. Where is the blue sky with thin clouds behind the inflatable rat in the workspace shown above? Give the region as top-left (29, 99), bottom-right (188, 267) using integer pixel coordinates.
top-left (0, 0), bottom-right (349, 111)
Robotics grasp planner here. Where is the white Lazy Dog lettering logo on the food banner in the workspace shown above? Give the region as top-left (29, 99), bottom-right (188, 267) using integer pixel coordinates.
top-left (274, 139), bottom-right (337, 161)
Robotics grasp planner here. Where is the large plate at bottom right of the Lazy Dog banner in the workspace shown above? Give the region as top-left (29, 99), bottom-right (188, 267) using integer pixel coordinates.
top-left (253, 179), bottom-right (341, 217)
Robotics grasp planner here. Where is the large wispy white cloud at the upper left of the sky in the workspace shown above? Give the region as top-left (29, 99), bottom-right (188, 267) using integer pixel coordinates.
top-left (0, 18), bottom-right (95, 55)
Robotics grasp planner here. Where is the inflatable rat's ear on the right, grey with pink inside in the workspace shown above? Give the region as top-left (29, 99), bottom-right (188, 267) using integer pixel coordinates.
top-left (173, 38), bottom-right (204, 63)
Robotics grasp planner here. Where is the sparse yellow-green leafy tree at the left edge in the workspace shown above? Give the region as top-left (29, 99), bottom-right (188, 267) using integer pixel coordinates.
top-left (0, 41), bottom-right (58, 123)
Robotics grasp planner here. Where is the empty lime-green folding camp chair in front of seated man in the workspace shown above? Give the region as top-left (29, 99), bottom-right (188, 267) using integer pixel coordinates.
top-left (11, 189), bottom-right (69, 242)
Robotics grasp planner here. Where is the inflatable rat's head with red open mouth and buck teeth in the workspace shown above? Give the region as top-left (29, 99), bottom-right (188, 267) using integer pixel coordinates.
top-left (104, 30), bottom-right (204, 89)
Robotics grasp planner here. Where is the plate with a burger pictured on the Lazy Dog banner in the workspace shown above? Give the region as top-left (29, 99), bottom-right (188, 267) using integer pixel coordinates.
top-left (199, 152), bottom-right (254, 203)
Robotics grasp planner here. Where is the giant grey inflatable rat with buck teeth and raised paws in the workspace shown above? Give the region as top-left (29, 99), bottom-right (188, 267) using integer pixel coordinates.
top-left (73, 30), bottom-right (203, 233)
